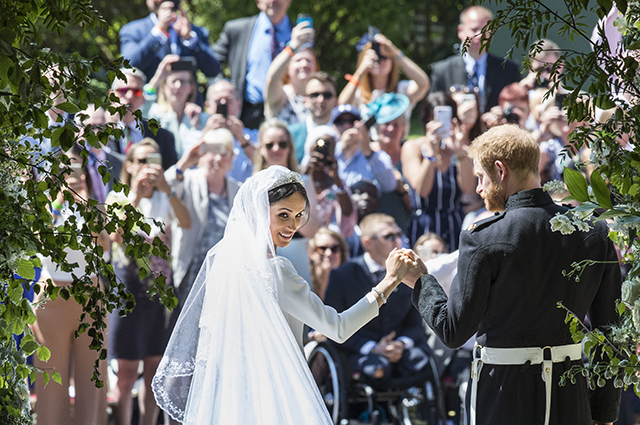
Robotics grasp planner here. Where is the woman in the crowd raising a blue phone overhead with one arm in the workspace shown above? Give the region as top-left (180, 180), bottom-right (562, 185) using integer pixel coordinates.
top-left (264, 15), bottom-right (319, 125)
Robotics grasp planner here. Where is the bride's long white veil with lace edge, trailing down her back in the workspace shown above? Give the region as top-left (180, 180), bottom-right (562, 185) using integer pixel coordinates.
top-left (152, 166), bottom-right (331, 425)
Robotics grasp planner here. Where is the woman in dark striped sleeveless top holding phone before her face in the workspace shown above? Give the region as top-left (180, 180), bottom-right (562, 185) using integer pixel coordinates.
top-left (402, 92), bottom-right (475, 251)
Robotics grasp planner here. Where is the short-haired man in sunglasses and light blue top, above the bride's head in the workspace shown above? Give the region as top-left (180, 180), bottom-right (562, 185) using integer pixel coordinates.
top-left (288, 71), bottom-right (338, 163)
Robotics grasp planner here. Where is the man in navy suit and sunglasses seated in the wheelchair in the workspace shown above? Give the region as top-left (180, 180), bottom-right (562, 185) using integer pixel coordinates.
top-left (325, 213), bottom-right (429, 380)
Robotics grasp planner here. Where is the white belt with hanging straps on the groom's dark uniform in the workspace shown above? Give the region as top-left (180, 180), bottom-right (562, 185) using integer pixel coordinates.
top-left (471, 344), bottom-right (582, 425)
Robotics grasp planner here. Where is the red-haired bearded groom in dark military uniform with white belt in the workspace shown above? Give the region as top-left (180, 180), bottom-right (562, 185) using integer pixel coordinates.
top-left (404, 125), bottom-right (621, 425)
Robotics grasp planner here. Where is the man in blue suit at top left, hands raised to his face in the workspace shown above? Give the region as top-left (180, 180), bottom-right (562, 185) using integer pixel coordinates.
top-left (120, 0), bottom-right (220, 86)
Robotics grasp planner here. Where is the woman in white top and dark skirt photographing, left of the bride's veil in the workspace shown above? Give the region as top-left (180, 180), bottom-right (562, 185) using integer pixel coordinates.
top-left (107, 138), bottom-right (191, 425)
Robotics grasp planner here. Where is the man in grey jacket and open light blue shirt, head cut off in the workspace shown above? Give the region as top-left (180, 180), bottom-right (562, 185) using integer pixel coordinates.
top-left (213, 0), bottom-right (291, 129)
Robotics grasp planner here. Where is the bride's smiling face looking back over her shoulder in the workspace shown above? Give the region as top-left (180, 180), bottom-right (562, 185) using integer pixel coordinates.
top-left (269, 192), bottom-right (306, 248)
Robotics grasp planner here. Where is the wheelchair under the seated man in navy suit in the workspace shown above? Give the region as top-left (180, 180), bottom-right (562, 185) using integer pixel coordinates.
top-left (305, 341), bottom-right (444, 425)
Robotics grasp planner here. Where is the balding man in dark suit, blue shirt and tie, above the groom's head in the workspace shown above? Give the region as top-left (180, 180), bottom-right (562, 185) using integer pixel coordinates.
top-left (431, 6), bottom-right (521, 112)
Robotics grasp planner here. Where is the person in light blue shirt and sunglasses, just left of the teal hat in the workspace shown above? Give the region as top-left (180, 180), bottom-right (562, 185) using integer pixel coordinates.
top-left (331, 103), bottom-right (397, 192)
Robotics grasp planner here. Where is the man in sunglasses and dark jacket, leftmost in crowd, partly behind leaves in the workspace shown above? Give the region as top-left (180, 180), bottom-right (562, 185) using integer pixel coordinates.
top-left (107, 68), bottom-right (178, 170)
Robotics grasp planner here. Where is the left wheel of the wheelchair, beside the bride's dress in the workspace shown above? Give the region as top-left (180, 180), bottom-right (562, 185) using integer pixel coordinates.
top-left (307, 343), bottom-right (349, 425)
